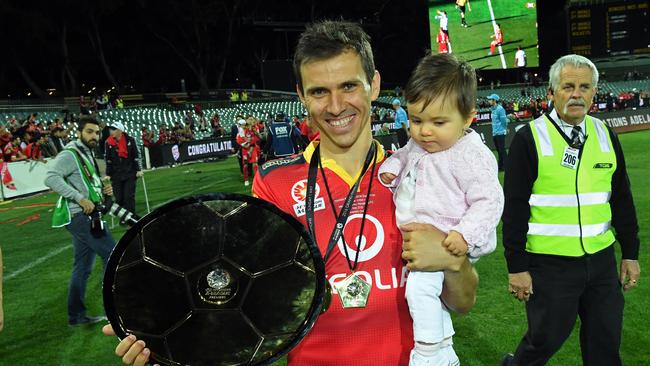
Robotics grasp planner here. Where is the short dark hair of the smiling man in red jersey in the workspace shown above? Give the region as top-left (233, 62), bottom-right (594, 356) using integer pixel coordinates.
top-left (293, 20), bottom-right (375, 91)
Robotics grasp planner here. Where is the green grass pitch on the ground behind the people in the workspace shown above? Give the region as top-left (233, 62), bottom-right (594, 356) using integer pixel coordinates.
top-left (0, 130), bottom-right (650, 366)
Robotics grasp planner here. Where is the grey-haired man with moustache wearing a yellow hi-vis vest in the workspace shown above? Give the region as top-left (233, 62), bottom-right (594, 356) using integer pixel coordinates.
top-left (502, 55), bottom-right (640, 366)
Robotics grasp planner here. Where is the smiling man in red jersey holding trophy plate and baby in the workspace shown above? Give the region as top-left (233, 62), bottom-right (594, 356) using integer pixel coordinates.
top-left (104, 21), bottom-right (477, 366)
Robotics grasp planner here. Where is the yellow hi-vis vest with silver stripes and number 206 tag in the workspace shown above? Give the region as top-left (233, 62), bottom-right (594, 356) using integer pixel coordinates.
top-left (526, 116), bottom-right (616, 257)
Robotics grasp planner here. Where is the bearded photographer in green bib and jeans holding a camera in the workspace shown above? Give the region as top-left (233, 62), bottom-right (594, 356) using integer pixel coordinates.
top-left (45, 116), bottom-right (115, 326)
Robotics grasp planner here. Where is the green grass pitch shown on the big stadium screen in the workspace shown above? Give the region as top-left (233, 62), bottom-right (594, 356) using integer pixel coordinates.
top-left (429, 0), bottom-right (539, 70)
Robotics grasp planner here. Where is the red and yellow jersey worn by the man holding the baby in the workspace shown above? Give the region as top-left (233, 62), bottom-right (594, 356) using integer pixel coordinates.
top-left (253, 143), bottom-right (413, 366)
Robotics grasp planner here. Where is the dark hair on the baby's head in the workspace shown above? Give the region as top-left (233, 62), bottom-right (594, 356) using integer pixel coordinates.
top-left (404, 53), bottom-right (476, 118)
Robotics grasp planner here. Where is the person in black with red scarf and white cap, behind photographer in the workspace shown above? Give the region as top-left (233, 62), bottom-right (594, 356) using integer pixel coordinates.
top-left (106, 122), bottom-right (142, 213)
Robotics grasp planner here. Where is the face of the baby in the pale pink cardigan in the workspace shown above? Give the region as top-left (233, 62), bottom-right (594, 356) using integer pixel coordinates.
top-left (407, 98), bottom-right (474, 153)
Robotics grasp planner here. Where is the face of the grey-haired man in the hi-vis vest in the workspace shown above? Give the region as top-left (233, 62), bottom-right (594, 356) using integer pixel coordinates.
top-left (553, 65), bottom-right (596, 125)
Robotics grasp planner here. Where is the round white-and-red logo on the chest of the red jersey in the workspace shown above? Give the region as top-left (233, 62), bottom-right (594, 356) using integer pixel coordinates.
top-left (337, 214), bottom-right (384, 262)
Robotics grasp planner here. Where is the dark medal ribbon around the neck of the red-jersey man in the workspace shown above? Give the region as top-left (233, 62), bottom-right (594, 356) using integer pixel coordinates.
top-left (305, 142), bottom-right (377, 271)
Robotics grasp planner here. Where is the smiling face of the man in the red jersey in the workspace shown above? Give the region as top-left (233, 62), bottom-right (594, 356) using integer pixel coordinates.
top-left (298, 51), bottom-right (380, 151)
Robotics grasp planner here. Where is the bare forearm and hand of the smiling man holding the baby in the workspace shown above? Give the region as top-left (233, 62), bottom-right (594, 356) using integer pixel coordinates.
top-left (400, 223), bottom-right (478, 314)
